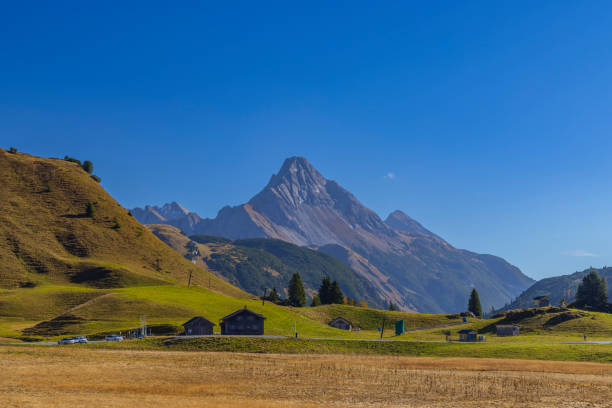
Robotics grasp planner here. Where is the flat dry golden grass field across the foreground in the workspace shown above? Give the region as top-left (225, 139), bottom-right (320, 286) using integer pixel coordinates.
top-left (0, 346), bottom-right (612, 408)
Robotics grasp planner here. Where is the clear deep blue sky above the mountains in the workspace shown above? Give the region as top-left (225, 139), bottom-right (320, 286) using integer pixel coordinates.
top-left (0, 1), bottom-right (612, 278)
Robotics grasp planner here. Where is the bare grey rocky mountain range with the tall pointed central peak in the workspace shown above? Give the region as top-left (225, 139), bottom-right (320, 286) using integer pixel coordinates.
top-left (132, 157), bottom-right (533, 313)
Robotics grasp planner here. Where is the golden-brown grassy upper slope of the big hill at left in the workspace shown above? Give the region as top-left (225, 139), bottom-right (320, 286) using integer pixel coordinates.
top-left (0, 149), bottom-right (241, 296)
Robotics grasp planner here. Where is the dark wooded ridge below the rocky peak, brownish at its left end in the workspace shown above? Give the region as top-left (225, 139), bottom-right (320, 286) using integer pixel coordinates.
top-left (147, 224), bottom-right (385, 307)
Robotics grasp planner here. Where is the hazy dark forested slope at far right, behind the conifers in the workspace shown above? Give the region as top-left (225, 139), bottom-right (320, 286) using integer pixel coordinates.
top-left (501, 268), bottom-right (612, 311)
